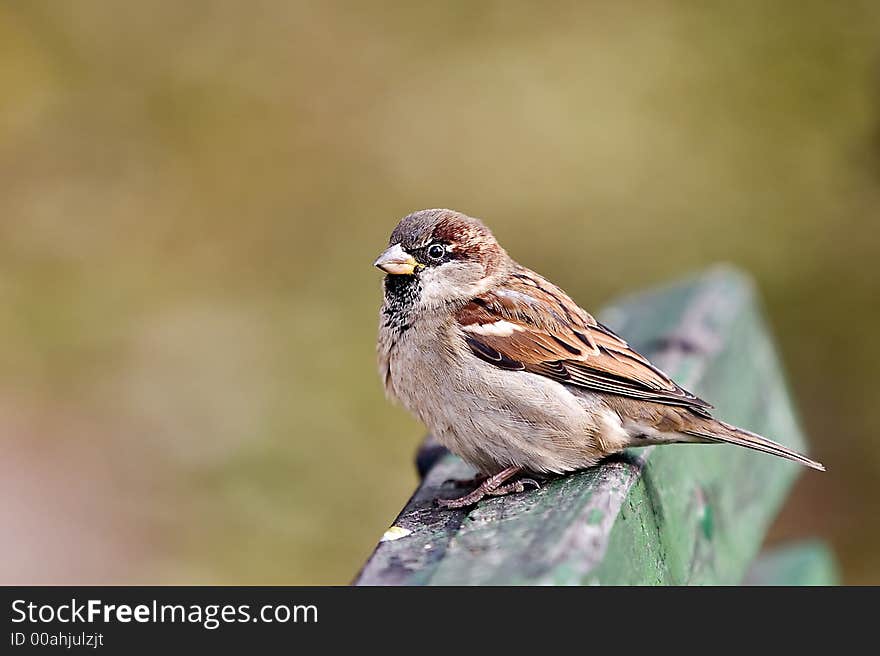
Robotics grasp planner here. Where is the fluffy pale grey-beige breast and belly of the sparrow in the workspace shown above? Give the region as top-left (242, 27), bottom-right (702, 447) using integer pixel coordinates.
top-left (388, 324), bottom-right (616, 472)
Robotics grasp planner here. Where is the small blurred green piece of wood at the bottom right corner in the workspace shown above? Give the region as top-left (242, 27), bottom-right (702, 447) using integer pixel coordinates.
top-left (744, 540), bottom-right (840, 586)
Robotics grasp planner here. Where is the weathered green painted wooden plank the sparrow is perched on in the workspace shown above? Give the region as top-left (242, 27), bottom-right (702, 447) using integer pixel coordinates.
top-left (355, 268), bottom-right (819, 585)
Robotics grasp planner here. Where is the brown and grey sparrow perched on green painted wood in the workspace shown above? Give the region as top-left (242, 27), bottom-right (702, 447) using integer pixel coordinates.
top-left (374, 209), bottom-right (825, 508)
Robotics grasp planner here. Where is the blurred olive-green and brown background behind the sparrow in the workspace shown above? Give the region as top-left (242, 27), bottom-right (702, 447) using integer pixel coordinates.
top-left (0, 0), bottom-right (880, 584)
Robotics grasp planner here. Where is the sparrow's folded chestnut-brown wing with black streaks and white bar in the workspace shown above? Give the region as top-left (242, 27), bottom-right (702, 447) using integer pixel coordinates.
top-left (456, 268), bottom-right (712, 416)
